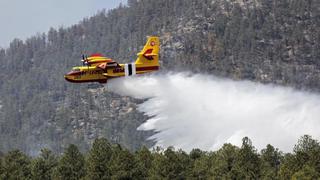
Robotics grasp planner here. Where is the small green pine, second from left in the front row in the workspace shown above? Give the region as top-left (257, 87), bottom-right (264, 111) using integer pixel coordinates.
top-left (31, 149), bottom-right (58, 180)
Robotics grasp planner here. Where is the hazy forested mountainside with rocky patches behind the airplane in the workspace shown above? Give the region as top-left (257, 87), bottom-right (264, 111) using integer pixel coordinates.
top-left (0, 0), bottom-right (320, 154)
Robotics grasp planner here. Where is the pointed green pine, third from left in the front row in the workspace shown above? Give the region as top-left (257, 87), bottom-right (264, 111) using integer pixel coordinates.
top-left (55, 144), bottom-right (85, 180)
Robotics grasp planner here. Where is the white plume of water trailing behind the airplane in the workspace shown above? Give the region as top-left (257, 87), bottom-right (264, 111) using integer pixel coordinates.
top-left (108, 73), bottom-right (320, 152)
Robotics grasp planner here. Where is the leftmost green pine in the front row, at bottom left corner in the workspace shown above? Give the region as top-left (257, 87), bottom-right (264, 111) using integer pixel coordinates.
top-left (1, 150), bottom-right (31, 179)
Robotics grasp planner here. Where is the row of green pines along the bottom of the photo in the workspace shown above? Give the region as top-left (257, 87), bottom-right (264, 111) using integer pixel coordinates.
top-left (0, 135), bottom-right (320, 180)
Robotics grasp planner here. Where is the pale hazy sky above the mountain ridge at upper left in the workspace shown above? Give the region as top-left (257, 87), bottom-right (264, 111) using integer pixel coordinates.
top-left (0, 0), bottom-right (127, 48)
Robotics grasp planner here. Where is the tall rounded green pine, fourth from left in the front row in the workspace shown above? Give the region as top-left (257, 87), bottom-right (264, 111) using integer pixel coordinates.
top-left (87, 138), bottom-right (112, 180)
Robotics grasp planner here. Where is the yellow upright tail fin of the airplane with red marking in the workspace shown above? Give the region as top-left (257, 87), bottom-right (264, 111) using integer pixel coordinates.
top-left (136, 36), bottom-right (160, 66)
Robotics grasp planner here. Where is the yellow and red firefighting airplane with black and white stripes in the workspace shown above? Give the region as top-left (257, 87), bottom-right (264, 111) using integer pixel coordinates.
top-left (64, 36), bottom-right (160, 83)
